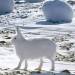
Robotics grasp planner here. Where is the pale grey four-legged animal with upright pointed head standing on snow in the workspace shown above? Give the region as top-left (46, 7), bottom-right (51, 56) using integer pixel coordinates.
top-left (12, 27), bottom-right (56, 70)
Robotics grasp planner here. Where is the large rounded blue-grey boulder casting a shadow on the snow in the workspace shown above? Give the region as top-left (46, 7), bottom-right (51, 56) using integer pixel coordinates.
top-left (42, 0), bottom-right (73, 22)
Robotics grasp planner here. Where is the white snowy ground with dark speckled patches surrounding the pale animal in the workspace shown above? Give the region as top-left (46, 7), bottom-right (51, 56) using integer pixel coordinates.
top-left (0, 2), bottom-right (75, 73)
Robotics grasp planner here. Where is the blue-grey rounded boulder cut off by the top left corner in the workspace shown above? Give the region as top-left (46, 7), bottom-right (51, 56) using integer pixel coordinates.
top-left (0, 0), bottom-right (14, 14)
